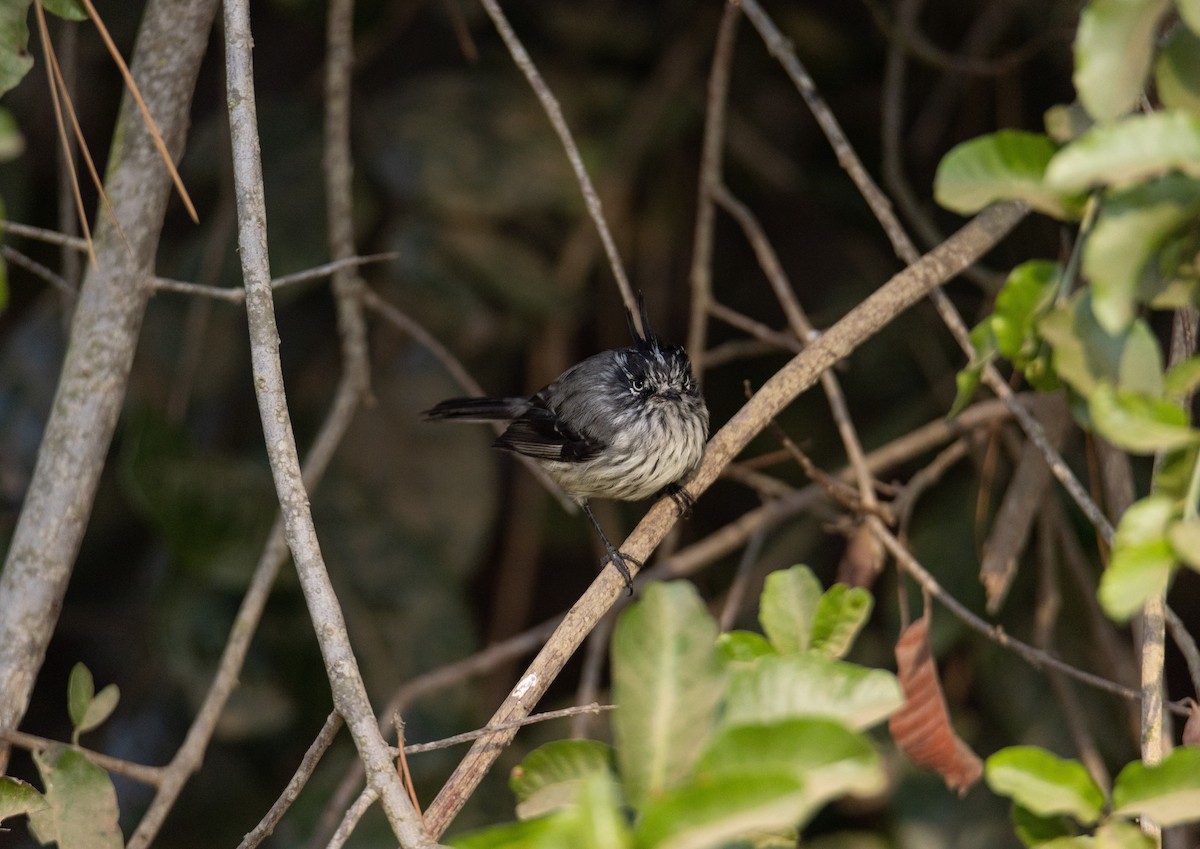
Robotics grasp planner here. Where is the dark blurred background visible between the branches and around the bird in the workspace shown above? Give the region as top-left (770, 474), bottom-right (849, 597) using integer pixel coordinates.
top-left (7, 0), bottom-right (1195, 849)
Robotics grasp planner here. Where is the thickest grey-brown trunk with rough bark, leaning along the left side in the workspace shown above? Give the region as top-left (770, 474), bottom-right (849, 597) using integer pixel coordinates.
top-left (0, 0), bottom-right (216, 770)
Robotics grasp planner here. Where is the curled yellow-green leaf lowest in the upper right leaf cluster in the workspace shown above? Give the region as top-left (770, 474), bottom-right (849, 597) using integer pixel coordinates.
top-left (1098, 495), bottom-right (1178, 621)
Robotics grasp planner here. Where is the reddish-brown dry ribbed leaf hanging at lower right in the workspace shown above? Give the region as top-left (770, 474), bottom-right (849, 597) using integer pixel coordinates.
top-left (888, 610), bottom-right (983, 795)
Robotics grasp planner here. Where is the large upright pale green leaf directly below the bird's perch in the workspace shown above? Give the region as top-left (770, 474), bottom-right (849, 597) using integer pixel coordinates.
top-left (612, 580), bottom-right (724, 807)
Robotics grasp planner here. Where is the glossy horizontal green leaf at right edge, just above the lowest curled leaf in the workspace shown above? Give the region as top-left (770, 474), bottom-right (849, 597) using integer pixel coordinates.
top-left (1087, 383), bottom-right (1200, 454)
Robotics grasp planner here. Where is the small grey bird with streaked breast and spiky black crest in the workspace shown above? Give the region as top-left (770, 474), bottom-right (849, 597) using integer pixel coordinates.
top-left (421, 297), bottom-right (708, 594)
